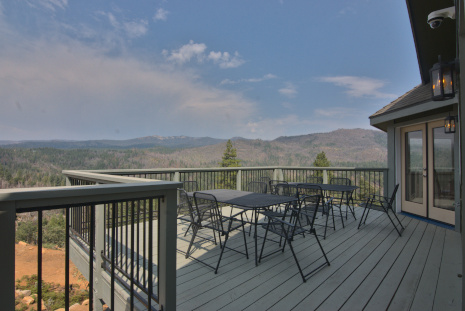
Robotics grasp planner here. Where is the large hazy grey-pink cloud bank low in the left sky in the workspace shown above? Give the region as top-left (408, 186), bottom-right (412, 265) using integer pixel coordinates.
top-left (0, 38), bottom-right (257, 139)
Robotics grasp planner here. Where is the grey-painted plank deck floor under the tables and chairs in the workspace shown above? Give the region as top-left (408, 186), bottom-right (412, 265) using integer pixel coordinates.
top-left (177, 208), bottom-right (462, 310)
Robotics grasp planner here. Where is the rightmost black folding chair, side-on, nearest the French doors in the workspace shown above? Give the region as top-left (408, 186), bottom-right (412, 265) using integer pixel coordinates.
top-left (358, 184), bottom-right (405, 236)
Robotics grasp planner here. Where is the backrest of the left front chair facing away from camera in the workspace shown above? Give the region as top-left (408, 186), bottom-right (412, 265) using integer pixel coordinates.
top-left (192, 192), bottom-right (224, 231)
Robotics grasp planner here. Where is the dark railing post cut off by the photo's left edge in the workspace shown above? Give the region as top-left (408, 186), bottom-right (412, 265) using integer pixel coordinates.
top-left (0, 202), bottom-right (16, 310)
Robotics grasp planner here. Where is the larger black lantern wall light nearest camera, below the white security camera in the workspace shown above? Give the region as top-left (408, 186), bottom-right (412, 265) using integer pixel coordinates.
top-left (429, 56), bottom-right (458, 100)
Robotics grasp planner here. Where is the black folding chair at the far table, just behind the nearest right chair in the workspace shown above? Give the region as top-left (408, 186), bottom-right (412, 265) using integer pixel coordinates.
top-left (297, 185), bottom-right (336, 239)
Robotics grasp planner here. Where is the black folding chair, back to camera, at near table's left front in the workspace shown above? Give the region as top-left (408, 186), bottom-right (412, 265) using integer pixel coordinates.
top-left (186, 192), bottom-right (249, 274)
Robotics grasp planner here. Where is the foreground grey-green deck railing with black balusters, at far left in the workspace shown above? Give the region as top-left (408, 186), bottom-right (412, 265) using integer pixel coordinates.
top-left (0, 178), bottom-right (180, 310)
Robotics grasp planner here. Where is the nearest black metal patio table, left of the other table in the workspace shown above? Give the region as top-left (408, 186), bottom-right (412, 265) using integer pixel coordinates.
top-left (188, 189), bottom-right (296, 265)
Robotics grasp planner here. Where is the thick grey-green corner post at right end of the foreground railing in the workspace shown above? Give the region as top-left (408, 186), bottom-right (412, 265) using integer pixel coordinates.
top-left (158, 189), bottom-right (177, 311)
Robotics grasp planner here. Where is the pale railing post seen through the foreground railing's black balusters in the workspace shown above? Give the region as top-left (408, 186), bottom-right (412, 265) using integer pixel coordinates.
top-left (93, 205), bottom-right (105, 310)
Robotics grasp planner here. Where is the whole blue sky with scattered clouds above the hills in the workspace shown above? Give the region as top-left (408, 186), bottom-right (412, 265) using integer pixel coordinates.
top-left (0, 0), bottom-right (418, 140)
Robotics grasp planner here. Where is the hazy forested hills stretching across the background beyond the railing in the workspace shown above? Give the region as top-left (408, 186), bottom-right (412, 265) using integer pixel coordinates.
top-left (0, 129), bottom-right (387, 188)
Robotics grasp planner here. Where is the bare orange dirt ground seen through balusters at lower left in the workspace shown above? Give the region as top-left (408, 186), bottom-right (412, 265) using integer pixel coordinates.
top-left (15, 242), bottom-right (87, 289)
